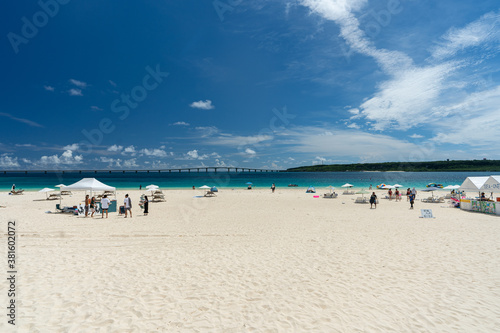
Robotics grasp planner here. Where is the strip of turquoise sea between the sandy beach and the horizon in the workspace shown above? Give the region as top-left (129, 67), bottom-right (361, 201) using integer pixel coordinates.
top-left (0, 172), bottom-right (492, 191)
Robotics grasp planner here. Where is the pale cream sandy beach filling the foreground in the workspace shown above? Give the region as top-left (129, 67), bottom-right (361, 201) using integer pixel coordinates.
top-left (0, 189), bottom-right (500, 332)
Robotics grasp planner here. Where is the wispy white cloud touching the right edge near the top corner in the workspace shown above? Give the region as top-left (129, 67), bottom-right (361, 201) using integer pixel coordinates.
top-left (432, 12), bottom-right (500, 59)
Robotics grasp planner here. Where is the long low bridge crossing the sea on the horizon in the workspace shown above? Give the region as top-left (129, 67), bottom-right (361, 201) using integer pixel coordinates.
top-left (0, 167), bottom-right (285, 174)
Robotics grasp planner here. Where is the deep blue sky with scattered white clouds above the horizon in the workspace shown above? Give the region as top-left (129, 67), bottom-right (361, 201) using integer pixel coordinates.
top-left (0, 0), bottom-right (500, 169)
